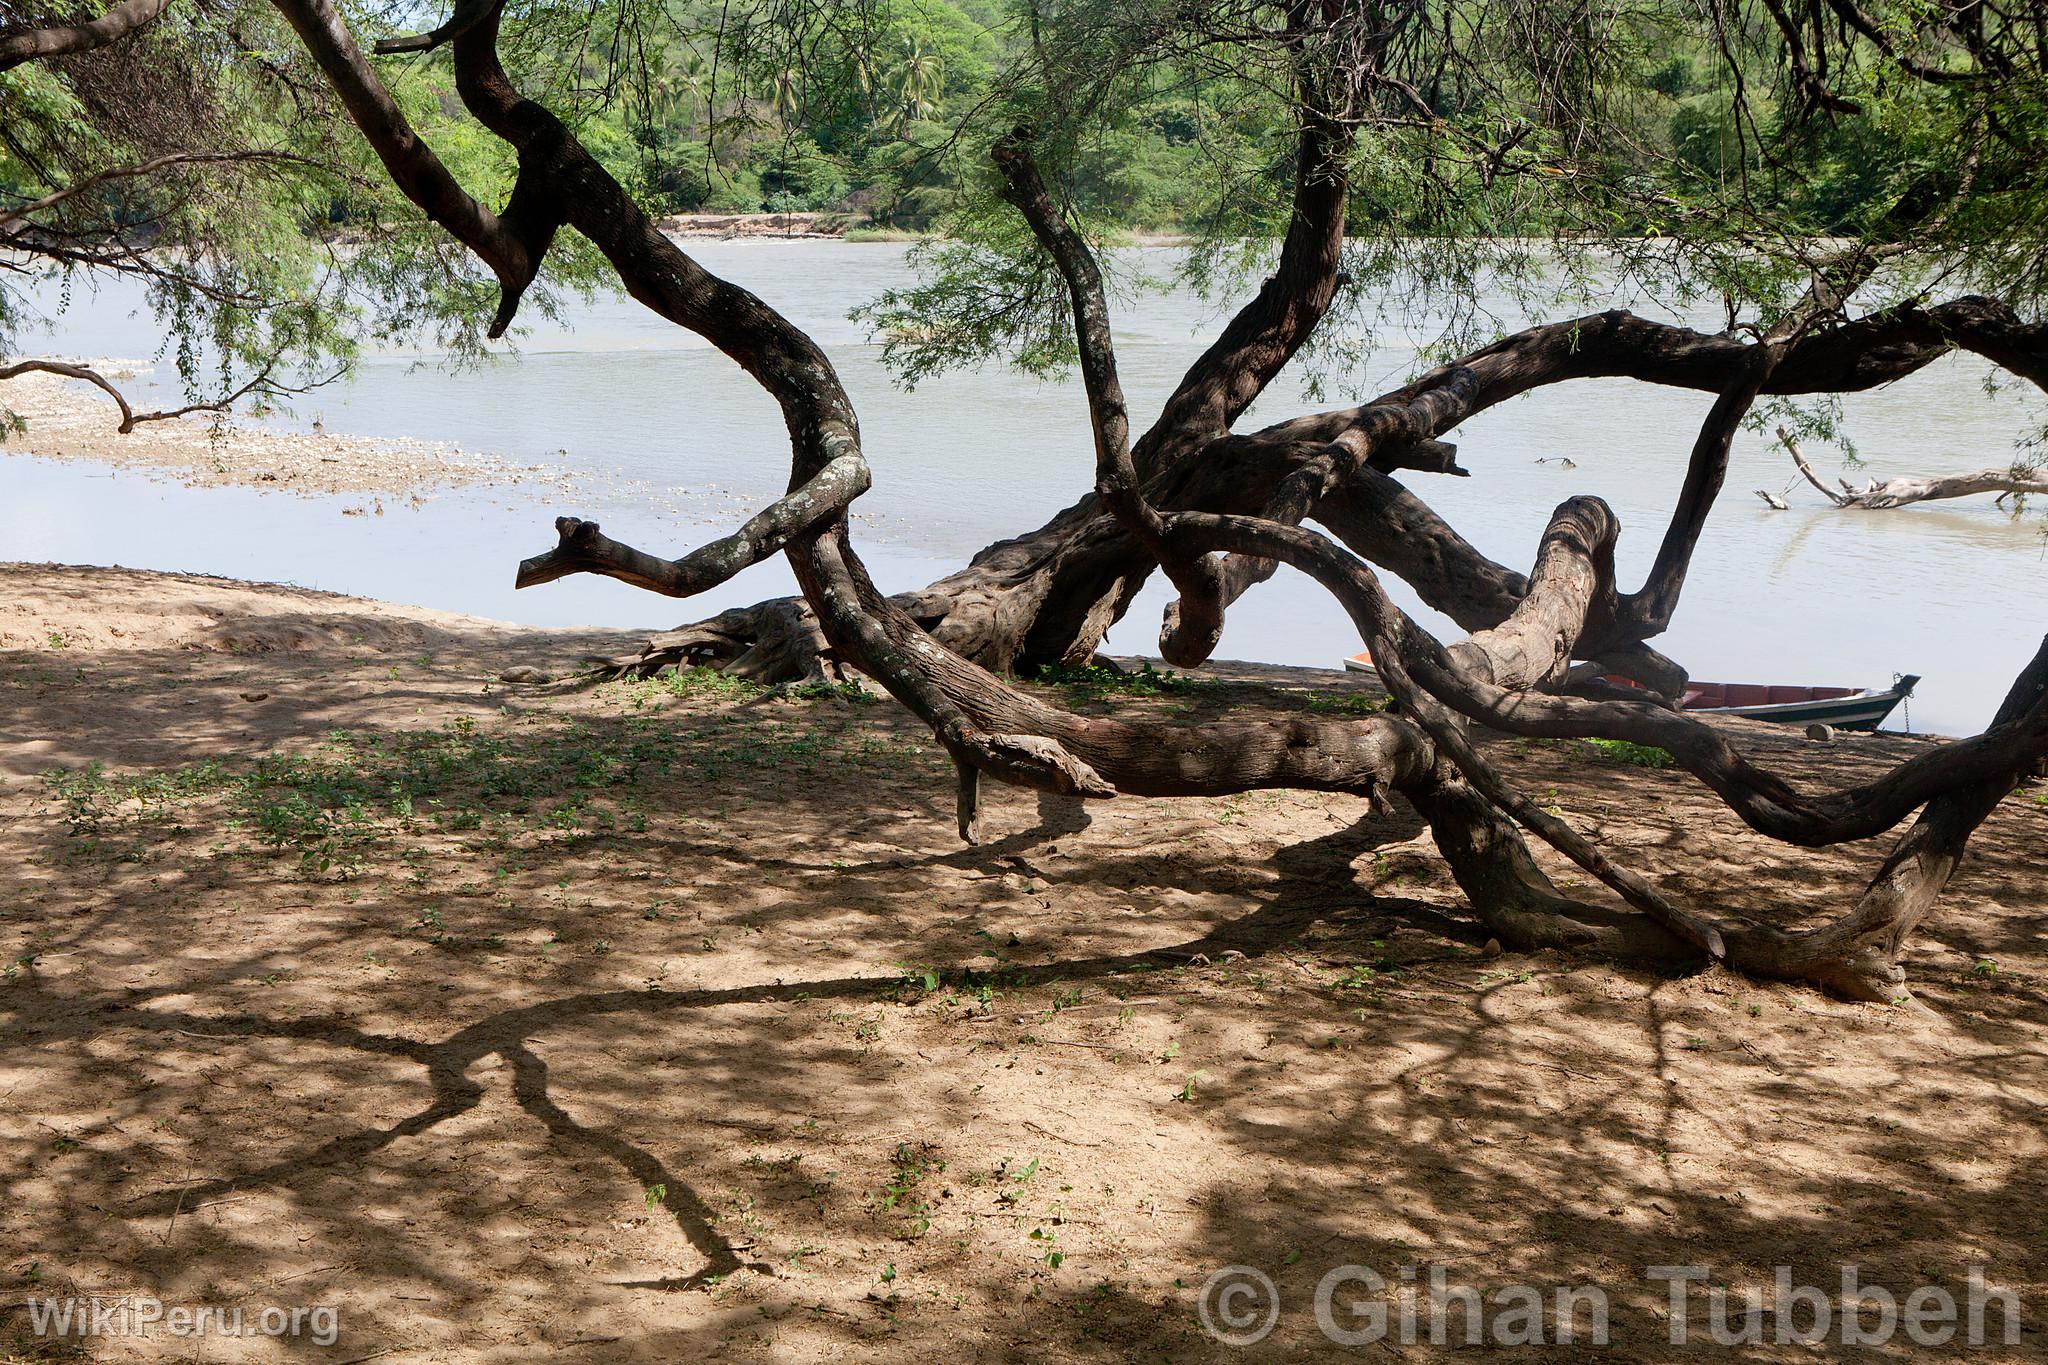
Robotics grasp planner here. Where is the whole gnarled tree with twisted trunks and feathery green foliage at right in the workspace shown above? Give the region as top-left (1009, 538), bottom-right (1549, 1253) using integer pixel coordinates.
top-left (23, 0), bottom-right (2048, 1001)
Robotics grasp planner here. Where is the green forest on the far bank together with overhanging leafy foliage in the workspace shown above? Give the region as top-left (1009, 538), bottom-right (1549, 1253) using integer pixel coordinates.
top-left (0, 0), bottom-right (2048, 395)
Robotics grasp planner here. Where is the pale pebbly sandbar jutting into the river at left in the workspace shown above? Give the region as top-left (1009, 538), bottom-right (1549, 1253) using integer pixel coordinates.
top-left (0, 360), bottom-right (544, 501)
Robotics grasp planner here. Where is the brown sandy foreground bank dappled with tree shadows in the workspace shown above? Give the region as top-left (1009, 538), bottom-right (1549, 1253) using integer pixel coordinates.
top-left (0, 567), bottom-right (2048, 1365)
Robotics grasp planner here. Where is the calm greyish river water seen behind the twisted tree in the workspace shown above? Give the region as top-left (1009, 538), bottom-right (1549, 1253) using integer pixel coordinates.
top-left (0, 239), bottom-right (2048, 733)
